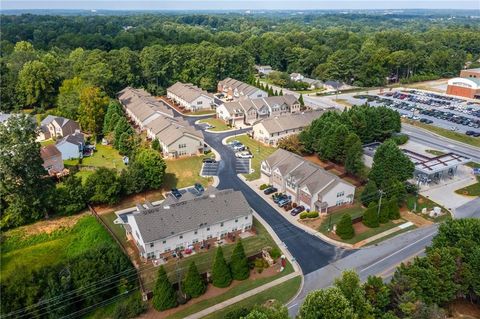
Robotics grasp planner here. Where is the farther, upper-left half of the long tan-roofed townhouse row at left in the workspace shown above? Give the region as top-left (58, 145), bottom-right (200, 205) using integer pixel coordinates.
top-left (117, 87), bottom-right (174, 130)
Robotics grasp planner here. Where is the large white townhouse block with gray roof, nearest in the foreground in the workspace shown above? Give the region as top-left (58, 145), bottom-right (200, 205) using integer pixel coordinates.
top-left (123, 189), bottom-right (253, 259)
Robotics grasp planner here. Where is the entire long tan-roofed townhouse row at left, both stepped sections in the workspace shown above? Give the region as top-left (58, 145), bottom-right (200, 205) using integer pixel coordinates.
top-left (118, 87), bottom-right (208, 157)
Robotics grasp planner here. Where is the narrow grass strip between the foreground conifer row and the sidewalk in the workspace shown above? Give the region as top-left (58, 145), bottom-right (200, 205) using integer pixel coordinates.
top-left (168, 263), bottom-right (298, 319)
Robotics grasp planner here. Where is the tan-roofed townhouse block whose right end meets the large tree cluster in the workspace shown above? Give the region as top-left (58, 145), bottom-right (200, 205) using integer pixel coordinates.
top-left (253, 110), bottom-right (324, 146)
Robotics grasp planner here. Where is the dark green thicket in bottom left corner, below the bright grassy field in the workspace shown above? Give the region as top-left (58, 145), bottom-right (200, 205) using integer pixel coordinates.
top-left (1, 246), bottom-right (136, 318)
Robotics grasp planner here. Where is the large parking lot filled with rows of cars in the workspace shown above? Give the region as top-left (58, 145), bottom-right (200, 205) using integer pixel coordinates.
top-left (355, 90), bottom-right (480, 137)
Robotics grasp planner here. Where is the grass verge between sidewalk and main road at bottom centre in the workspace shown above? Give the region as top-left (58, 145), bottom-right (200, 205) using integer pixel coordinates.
top-left (202, 276), bottom-right (302, 319)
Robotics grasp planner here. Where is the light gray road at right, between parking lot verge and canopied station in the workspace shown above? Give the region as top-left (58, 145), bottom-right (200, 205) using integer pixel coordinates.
top-left (402, 123), bottom-right (480, 162)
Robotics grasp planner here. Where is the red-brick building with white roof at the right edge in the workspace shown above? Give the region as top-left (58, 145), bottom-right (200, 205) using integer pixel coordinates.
top-left (447, 68), bottom-right (480, 99)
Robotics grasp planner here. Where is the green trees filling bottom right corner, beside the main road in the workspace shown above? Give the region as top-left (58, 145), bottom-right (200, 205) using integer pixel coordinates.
top-left (299, 219), bottom-right (480, 319)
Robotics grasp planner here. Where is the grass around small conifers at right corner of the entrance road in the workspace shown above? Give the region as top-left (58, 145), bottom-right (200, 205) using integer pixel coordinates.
top-left (319, 204), bottom-right (405, 244)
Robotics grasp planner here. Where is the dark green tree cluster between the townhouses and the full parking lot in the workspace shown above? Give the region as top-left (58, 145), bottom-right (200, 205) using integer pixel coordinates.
top-left (299, 105), bottom-right (401, 175)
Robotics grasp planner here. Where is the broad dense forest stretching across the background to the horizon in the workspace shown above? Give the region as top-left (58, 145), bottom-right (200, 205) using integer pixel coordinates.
top-left (0, 14), bottom-right (480, 109)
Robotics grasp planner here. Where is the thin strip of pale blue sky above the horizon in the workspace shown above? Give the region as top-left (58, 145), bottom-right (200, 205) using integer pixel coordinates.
top-left (0, 0), bottom-right (480, 10)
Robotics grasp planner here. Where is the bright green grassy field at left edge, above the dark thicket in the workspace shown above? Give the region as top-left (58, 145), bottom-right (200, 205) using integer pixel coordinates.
top-left (0, 216), bottom-right (116, 280)
